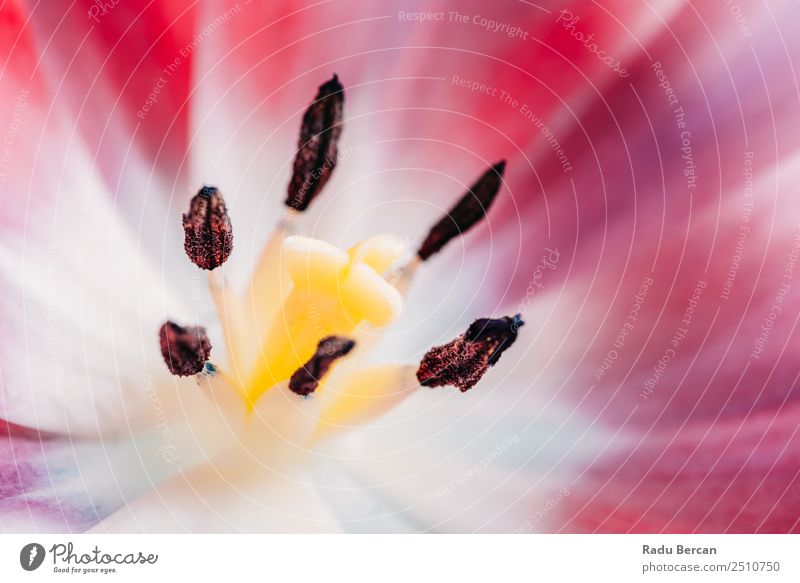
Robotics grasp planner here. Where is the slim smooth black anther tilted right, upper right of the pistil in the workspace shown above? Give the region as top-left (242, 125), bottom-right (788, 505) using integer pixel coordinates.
top-left (417, 160), bottom-right (506, 261)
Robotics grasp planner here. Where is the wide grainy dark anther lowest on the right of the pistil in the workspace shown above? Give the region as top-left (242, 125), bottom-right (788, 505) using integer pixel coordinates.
top-left (417, 314), bottom-right (525, 393)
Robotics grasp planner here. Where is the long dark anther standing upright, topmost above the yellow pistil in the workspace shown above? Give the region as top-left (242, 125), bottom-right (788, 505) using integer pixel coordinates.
top-left (285, 75), bottom-right (344, 211)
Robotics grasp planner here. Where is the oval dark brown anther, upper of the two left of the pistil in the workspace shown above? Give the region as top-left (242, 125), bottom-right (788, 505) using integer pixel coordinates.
top-left (183, 186), bottom-right (233, 269)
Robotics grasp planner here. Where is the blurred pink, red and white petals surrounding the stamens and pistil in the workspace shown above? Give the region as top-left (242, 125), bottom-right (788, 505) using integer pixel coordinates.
top-left (0, 0), bottom-right (800, 533)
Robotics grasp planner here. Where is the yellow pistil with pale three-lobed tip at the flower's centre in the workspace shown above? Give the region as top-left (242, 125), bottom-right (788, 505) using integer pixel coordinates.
top-left (243, 235), bottom-right (405, 409)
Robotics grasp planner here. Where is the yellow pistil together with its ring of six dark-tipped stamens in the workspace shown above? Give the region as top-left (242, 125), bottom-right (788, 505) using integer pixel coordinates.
top-left (159, 75), bottom-right (523, 456)
